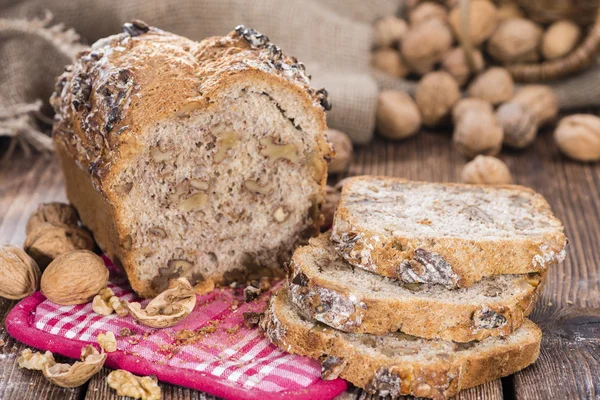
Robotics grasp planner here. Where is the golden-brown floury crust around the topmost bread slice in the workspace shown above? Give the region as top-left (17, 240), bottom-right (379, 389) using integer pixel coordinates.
top-left (331, 176), bottom-right (568, 288)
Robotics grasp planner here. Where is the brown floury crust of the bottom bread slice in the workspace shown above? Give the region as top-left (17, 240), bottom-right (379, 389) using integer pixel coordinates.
top-left (261, 289), bottom-right (542, 399)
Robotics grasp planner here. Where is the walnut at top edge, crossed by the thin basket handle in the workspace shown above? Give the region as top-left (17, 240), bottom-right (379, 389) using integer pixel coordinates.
top-left (448, 0), bottom-right (498, 46)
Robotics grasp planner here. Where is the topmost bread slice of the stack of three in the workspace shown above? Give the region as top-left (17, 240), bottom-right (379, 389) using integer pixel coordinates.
top-left (331, 176), bottom-right (567, 288)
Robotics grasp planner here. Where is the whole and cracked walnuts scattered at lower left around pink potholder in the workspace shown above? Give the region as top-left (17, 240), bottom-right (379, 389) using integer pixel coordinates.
top-left (0, 203), bottom-right (216, 400)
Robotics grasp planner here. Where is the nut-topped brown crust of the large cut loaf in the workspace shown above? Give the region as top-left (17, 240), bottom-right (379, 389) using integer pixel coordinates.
top-left (51, 21), bottom-right (334, 297)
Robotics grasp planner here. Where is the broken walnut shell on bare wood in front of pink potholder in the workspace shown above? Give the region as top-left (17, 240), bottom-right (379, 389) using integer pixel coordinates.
top-left (42, 345), bottom-right (106, 388)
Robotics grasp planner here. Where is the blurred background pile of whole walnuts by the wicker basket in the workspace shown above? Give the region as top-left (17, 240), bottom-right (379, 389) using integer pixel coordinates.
top-left (372, 0), bottom-right (600, 183)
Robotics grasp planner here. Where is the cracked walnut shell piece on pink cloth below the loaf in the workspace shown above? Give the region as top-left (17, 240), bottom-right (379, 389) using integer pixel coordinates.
top-left (127, 278), bottom-right (196, 328)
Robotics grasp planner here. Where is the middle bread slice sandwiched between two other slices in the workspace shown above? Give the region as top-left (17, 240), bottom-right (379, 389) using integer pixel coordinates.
top-left (289, 234), bottom-right (545, 342)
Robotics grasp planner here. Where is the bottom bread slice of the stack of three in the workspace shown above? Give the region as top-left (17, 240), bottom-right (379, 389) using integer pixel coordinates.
top-left (261, 289), bottom-right (542, 399)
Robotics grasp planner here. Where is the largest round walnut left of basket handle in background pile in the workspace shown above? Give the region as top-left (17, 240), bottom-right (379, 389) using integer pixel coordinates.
top-left (400, 19), bottom-right (453, 75)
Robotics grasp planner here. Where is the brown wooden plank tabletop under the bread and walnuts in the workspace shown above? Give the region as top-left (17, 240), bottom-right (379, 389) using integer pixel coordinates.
top-left (0, 132), bottom-right (600, 400)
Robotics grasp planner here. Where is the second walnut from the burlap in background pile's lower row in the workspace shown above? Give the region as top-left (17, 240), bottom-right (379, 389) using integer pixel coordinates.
top-left (415, 71), bottom-right (460, 126)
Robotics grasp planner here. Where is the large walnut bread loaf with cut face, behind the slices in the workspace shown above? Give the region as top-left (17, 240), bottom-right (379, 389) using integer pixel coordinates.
top-left (51, 20), bottom-right (333, 297)
